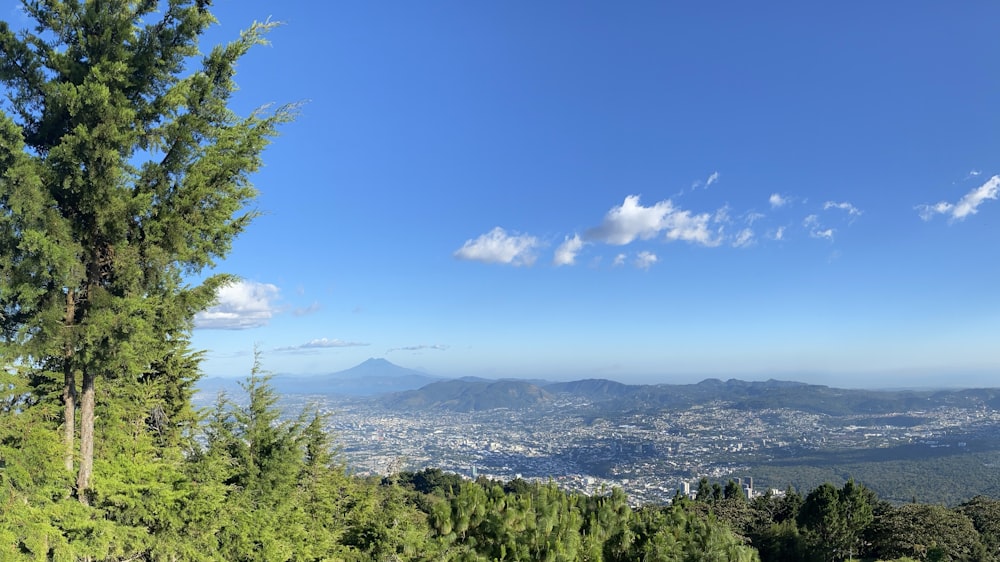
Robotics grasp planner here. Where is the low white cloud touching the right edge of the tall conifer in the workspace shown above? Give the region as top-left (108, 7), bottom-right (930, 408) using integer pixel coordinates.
top-left (194, 281), bottom-right (281, 330)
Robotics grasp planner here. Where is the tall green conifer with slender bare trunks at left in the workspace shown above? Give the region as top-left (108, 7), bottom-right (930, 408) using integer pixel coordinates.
top-left (0, 0), bottom-right (292, 501)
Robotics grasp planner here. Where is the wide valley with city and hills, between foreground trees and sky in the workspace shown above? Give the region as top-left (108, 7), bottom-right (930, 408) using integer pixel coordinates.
top-left (201, 362), bottom-right (1000, 504)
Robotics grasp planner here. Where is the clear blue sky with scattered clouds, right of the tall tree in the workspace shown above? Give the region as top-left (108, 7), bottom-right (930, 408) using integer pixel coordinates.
top-left (178, 0), bottom-right (1000, 387)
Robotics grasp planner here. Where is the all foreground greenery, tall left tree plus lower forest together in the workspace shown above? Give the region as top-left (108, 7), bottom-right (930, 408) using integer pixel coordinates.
top-left (0, 0), bottom-right (1000, 562)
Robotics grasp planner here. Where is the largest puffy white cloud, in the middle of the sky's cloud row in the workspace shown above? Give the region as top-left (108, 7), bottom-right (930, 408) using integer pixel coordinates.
top-left (586, 195), bottom-right (719, 246)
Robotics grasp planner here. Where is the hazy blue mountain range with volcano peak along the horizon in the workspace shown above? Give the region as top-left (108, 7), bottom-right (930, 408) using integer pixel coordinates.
top-left (193, 358), bottom-right (1000, 415)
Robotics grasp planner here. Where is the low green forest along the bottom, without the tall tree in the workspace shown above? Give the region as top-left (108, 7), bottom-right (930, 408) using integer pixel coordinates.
top-left (0, 356), bottom-right (1000, 562)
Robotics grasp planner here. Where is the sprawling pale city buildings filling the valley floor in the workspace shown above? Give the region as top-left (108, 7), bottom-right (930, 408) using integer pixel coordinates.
top-left (258, 395), bottom-right (1000, 504)
